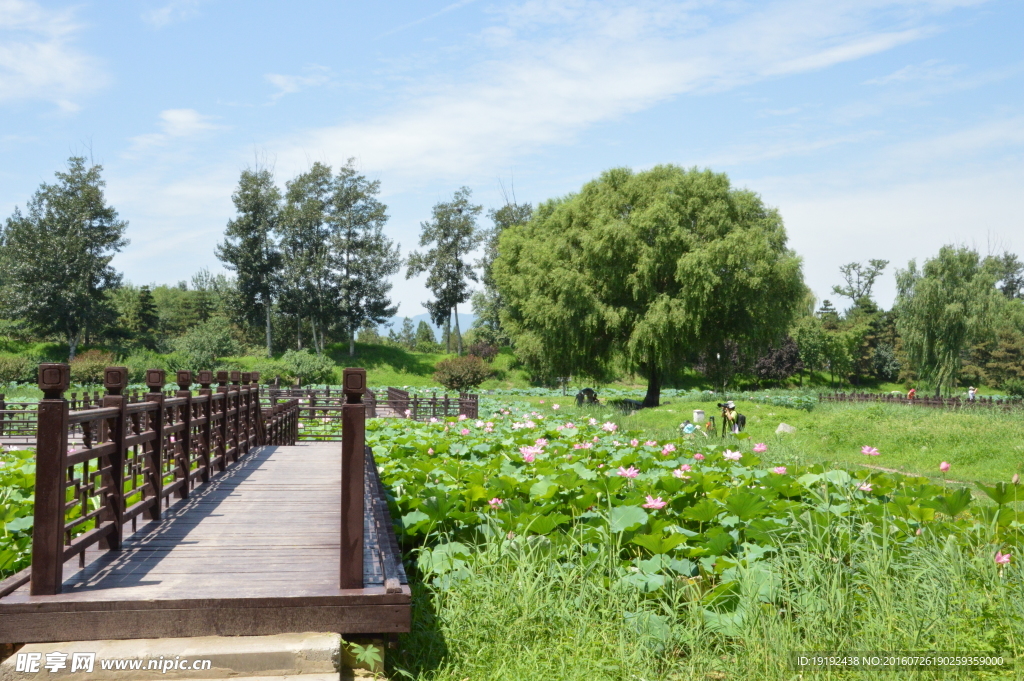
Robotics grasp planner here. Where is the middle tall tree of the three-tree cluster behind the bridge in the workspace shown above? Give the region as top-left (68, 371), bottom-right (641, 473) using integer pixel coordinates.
top-left (281, 163), bottom-right (338, 353)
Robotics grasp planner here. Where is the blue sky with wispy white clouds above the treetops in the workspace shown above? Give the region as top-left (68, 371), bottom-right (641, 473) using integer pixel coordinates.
top-left (0, 0), bottom-right (1024, 315)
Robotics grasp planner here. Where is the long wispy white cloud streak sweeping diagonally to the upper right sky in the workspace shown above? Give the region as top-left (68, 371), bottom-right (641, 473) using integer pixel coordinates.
top-left (274, 0), bottom-right (983, 183)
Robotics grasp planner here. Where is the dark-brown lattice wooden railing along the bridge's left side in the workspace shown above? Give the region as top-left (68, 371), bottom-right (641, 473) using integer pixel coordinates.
top-left (0, 364), bottom-right (299, 596)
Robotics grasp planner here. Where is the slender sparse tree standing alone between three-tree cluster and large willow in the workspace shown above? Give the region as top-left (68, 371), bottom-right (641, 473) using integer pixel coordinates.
top-left (406, 186), bottom-right (483, 354)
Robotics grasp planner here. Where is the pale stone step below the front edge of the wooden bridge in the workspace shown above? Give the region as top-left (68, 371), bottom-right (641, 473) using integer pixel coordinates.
top-left (0, 633), bottom-right (351, 681)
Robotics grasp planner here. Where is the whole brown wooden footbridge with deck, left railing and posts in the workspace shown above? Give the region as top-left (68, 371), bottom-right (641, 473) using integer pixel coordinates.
top-left (0, 365), bottom-right (412, 643)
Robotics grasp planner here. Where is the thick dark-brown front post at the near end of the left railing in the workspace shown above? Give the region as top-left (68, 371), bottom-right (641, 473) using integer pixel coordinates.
top-left (29, 364), bottom-right (71, 596)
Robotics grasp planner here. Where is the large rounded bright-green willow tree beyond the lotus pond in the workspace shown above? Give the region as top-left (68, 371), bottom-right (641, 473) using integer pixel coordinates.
top-left (494, 165), bottom-right (805, 407)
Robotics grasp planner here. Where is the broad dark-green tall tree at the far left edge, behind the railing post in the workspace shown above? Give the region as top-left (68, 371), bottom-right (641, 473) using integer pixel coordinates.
top-left (0, 157), bottom-right (128, 359)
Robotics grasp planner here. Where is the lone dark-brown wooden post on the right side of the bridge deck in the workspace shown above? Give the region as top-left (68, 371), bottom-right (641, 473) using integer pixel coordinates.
top-left (339, 369), bottom-right (367, 589)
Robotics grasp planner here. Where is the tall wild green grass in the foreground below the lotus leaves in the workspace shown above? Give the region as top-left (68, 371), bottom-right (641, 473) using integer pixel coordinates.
top-left (388, 526), bottom-right (1024, 681)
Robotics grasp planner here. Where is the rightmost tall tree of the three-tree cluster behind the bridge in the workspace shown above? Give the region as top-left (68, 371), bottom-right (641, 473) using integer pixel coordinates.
top-left (331, 159), bottom-right (401, 356)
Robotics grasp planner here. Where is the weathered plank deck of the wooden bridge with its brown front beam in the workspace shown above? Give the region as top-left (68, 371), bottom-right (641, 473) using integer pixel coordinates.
top-left (0, 442), bottom-right (411, 643)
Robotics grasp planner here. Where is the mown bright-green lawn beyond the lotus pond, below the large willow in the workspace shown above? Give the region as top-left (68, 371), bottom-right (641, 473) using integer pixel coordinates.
top-left (509, 392), bottom-right (1024, 482)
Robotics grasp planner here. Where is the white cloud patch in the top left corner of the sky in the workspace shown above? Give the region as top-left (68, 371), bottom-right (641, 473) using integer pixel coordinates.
top-left (0, 0), bottom-right (108, 106)
